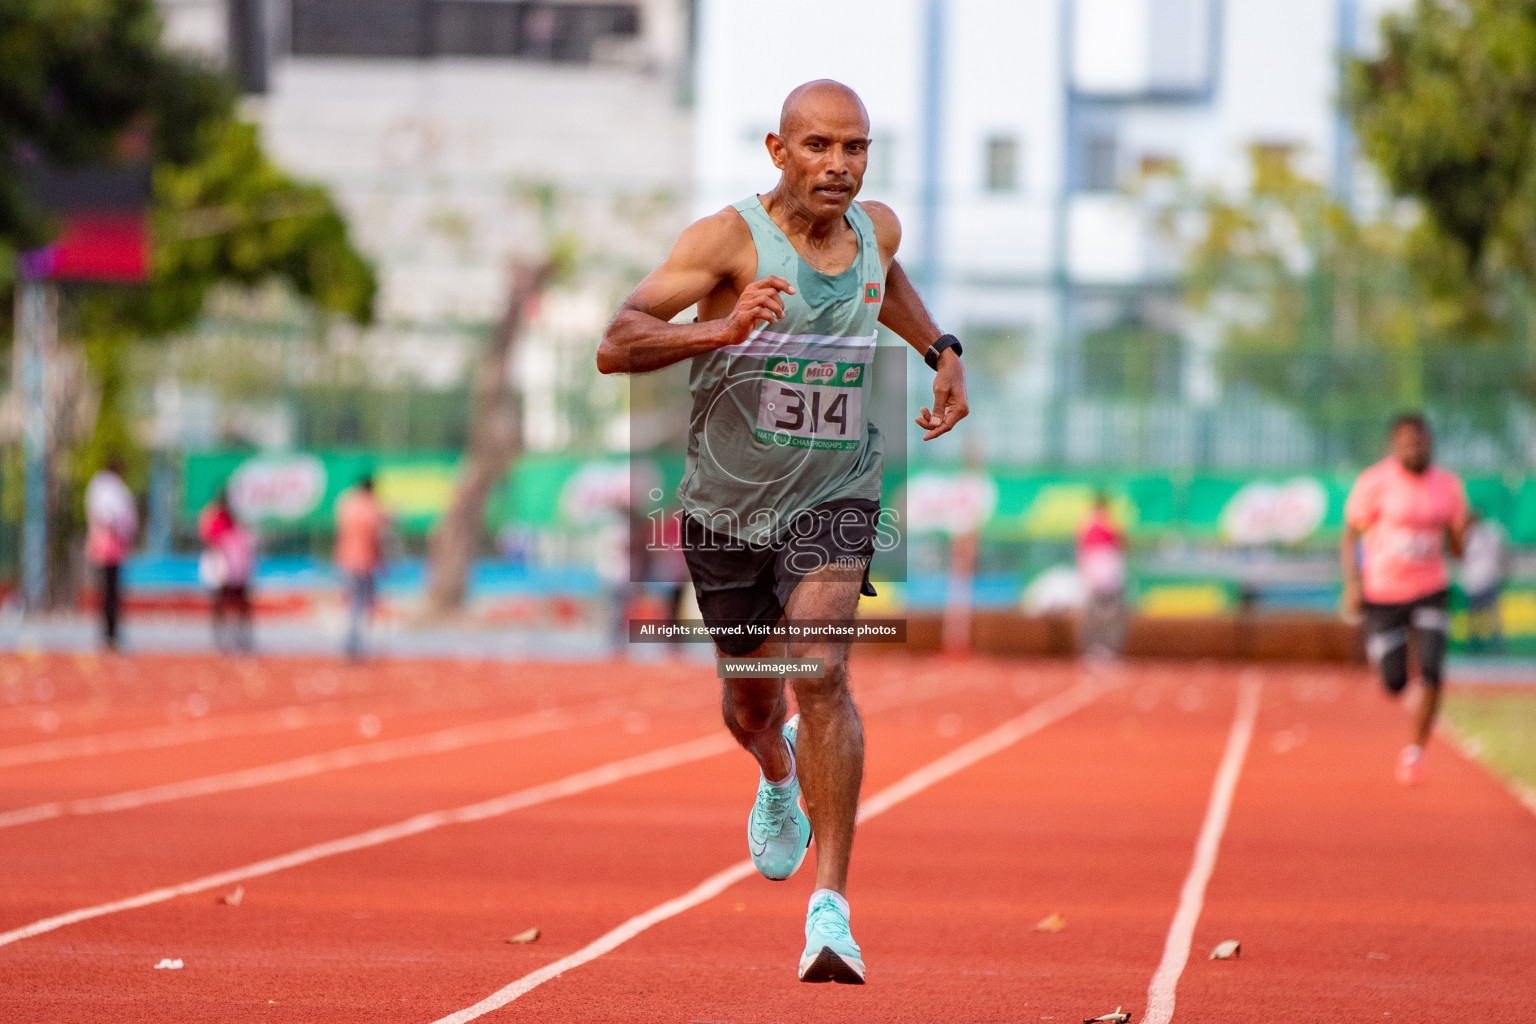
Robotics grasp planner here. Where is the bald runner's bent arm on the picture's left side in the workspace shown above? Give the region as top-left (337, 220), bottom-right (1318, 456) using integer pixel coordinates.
top-left (598, 210), bottom-right (794, 373)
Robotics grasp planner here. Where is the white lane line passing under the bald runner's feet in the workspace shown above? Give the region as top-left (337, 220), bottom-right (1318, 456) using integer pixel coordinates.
top-left (433, 679), bottom-right (1118, 1024)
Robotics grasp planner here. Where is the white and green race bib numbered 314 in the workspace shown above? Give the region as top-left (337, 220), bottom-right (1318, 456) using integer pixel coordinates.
top-left (753, 359), bottom-right (865, 451)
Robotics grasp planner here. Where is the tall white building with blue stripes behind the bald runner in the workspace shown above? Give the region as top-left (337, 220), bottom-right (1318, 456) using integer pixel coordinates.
top-left (694, 0), bottom-right (1401, 464)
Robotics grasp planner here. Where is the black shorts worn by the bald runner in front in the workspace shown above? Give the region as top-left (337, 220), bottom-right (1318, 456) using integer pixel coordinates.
top-left (682, 497), bottom-right (880, 657)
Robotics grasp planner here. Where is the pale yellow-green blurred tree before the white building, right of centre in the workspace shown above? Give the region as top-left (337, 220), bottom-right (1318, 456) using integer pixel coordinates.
top-left (1164, 146), bottom-right (1530, 420)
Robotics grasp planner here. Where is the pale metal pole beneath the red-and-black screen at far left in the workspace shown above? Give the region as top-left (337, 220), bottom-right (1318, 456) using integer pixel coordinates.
top-left (15, 273), bottom-right (58, 613)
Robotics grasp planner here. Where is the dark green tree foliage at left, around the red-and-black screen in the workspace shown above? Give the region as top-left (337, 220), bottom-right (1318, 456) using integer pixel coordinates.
top-left (0, 0), bottom-right (376, 568)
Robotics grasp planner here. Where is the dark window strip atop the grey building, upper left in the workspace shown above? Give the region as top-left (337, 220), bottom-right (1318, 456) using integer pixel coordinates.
top-left (290, 0), bottom-right (641, 63)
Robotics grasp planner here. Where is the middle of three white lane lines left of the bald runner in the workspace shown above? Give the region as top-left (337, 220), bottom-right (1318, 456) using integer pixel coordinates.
top-left (0, 700), bottom-right (624, 829)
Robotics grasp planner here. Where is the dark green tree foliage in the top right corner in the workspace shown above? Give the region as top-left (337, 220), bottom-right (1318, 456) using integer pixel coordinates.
top-left (1349, 0), bottom-right (1536, 332)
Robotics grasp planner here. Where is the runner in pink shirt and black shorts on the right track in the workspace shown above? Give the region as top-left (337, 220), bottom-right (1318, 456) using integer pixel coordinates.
top-left (1339, 413), bottom-right (1467, 785)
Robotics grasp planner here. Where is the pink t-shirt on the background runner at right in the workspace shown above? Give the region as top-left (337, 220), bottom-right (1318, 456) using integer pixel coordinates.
top-left (1344, 457), bottom-right (1467, 605)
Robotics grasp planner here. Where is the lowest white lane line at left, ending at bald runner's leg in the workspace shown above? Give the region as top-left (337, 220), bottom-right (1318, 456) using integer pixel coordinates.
top-left (0, 732), bottom-right (736, 946)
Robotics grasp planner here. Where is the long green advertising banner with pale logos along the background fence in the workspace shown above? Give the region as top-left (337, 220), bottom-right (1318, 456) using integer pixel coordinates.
top-left (181, 451), bottom-right (1536, 547)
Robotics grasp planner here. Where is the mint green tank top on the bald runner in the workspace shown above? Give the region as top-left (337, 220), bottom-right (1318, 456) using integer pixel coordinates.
top-left (677, 195), bottom-right (885, 545)
